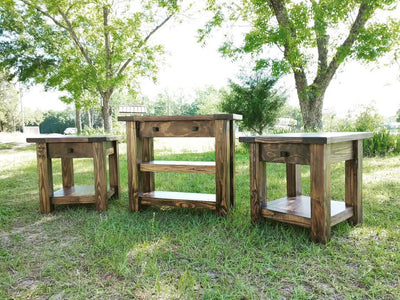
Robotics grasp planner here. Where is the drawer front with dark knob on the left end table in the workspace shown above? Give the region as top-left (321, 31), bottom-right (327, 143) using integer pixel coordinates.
top-left (47, 143), bottom-right (93, 158)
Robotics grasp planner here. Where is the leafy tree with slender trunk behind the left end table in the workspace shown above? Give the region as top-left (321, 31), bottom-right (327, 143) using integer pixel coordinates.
top-left (0, 0), bottom-right (179, 132)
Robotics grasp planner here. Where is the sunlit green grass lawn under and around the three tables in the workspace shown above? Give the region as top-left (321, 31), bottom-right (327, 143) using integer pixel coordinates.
top-left (0, 144), bottom-right (400, 299)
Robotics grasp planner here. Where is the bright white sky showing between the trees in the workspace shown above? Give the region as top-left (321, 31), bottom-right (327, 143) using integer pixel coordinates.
top-left (23, 7), bottom-right (400, 117)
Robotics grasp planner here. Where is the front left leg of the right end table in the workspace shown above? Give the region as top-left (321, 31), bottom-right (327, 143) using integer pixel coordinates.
top-left (249, 143), bottom-right (267, 224)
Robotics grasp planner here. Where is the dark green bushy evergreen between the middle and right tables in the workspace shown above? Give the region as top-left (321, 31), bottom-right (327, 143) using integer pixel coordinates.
top-left (221, 72), bottom-right (286, 134)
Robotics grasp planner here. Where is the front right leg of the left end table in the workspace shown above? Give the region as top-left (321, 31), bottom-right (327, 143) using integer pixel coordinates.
top-left (92, 143), bottom-right (107, 211)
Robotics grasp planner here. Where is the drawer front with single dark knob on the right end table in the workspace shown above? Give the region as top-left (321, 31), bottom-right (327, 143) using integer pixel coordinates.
top-left (260, 144), bottom-right (310, 165)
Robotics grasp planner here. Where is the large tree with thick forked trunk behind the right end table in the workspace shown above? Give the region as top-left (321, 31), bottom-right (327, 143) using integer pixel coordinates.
top-left (200, 0), bottom-right (400, 130)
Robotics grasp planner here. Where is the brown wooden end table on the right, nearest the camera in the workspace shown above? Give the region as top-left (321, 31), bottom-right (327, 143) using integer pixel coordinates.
top-left (239, 132), bottom-right (372, 243)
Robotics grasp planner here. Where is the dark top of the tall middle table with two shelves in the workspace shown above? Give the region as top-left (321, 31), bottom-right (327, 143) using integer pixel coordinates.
top-left (118, 114), bottom-right (242, 122)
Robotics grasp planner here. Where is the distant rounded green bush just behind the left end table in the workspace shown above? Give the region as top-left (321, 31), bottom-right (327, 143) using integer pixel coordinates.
top-left (39, 111), bottom-right (75, 134)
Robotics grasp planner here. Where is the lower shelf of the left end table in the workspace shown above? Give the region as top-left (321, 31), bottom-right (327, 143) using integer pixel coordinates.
top-left (50, 185), bottom-right (115, 204)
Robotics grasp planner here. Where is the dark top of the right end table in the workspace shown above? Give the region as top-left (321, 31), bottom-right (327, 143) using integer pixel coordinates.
top-left (239, 132), bottom-right (373, 144)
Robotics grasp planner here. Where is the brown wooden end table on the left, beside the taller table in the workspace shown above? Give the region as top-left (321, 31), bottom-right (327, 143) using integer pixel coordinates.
top-left (26, 136), bottom-right (120, 213)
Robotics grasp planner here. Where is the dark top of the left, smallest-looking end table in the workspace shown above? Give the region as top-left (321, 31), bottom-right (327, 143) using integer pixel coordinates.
top-left (26, 135), bottom-right (121, 143)
